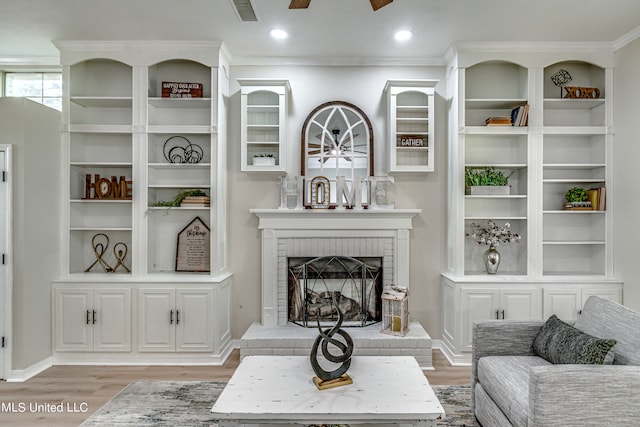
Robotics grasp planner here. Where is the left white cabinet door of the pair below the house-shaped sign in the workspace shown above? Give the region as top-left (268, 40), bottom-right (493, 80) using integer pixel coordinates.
top-left (138, 289), bottom-right (176, 352)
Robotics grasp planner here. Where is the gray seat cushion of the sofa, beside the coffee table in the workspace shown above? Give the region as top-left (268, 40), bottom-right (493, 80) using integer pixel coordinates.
top-left (478, 356), bottom-right (551, 426)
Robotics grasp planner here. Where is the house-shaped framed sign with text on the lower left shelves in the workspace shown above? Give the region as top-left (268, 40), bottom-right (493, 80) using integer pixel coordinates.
top-left (176, 217), bottom-right (211, 272)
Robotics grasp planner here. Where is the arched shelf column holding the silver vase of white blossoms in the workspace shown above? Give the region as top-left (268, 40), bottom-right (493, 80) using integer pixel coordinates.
top-left (459, 61), bottom-right (531, 276)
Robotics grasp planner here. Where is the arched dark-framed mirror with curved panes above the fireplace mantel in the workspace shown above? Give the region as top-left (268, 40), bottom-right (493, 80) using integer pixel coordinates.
top-left (300, 101), bottom-right (373, 206)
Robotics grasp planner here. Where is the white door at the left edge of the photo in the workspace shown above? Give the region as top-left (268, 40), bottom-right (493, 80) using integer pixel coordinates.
top-left (0, 145), bottom-right (12, 380)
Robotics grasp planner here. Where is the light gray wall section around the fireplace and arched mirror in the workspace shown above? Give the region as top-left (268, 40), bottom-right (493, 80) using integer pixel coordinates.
top-left (228, 66), bottom-right (447, 338)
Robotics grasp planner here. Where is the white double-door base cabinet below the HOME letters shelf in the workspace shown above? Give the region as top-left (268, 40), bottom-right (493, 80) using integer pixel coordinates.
top-left (53, 288), bottom-right (131, 352)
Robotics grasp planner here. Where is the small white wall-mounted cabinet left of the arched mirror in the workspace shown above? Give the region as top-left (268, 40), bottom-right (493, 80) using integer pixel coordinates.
top-left (238, 79), bottom-right (290, 172)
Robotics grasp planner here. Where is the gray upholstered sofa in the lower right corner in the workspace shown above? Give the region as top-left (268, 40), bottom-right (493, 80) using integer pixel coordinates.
top-left (471, 297), bottom-right (640, 427)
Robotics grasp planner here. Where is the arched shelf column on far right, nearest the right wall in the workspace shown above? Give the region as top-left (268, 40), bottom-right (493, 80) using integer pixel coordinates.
top-left (542, 61), bottom-right (613, 276)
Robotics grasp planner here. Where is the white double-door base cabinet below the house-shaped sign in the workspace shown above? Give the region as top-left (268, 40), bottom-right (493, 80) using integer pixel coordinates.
top-left (138, 288), bottom-right (214, 352)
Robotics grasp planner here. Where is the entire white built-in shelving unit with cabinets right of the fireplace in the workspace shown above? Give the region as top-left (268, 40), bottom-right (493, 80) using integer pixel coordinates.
top-left (442, 46), bottom-right (622, 363)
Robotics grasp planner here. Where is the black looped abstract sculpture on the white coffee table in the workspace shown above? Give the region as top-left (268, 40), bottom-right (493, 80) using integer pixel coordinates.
top-left (310, 298), bottom-right (353, 389)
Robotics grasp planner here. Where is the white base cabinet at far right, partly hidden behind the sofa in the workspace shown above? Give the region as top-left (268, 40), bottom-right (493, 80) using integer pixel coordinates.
top-left (544, 284), bottom-right (622, 321)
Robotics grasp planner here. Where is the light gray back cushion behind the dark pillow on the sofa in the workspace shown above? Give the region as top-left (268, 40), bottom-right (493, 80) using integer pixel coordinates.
top-left (575, 296), bottom-right (640, 365)
